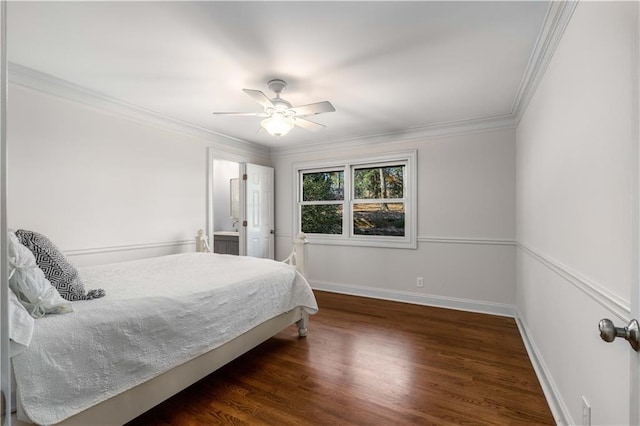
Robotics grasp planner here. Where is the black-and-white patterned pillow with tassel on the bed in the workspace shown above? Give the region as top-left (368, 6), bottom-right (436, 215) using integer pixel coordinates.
top-left (16, 229), bottom-right (105, 301)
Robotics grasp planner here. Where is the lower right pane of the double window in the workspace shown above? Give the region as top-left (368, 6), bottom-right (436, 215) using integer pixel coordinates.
top-left (353, 203), bottom-right (404, 237)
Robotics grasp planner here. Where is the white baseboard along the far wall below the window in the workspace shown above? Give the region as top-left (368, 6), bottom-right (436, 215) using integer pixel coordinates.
top-left (309, 280), bottom-right (516, 317)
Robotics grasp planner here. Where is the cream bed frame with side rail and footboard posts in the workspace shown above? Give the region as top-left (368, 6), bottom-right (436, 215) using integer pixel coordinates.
top-left (12, 233), bottom-right (309, 426)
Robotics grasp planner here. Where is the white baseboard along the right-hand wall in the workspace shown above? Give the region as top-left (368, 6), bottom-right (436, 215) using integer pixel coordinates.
top-left (514, 311), bottom-right (576, 425)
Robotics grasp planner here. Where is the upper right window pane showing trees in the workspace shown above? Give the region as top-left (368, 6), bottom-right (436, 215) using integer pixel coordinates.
top-left (353, 166), bottom-right (404, 200)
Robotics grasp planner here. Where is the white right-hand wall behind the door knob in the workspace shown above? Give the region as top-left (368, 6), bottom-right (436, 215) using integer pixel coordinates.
top-left (516, 2), bottom-right (638, 425)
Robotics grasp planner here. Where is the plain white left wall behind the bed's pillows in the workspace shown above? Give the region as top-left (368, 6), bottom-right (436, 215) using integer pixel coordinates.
top-left (8, 84), bottom-right (261, 265)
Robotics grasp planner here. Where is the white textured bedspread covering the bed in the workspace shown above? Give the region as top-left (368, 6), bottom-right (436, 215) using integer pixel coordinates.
top-left (13, 253), bottom-right (318, 424)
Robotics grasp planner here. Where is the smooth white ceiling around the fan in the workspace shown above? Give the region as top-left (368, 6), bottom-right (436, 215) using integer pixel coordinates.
top-left (7, 1), bottom-right (549, 148)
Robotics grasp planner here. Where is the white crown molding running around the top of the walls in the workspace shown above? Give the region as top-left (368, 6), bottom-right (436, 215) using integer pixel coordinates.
top-left (8, 1), bottom-right (578, 158)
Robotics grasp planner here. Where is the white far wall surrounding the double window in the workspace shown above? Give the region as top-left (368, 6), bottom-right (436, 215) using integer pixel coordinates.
top-left (274, 129), bottom-right (516, 313)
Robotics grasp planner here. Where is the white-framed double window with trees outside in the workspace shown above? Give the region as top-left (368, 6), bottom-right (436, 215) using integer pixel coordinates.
top-left (294, 151), bottom-right (417, 248)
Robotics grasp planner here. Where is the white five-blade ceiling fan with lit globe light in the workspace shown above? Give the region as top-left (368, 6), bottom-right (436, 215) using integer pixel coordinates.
top-left (213, 79), bottom-right (336, 137)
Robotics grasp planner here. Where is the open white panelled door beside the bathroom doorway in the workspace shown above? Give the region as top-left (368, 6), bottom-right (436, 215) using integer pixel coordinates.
top-left (240, 163), bottom-right (275, 259)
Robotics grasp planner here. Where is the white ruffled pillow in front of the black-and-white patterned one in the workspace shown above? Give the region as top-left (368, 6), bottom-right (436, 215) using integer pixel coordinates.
top-left (9, 232), bottom-right (73, 318)
